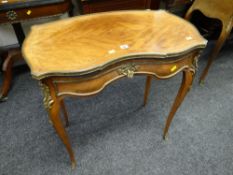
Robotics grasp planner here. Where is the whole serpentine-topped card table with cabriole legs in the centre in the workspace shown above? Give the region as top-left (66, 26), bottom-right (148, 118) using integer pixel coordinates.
top-left (23, 10), bottom-right (207, 167)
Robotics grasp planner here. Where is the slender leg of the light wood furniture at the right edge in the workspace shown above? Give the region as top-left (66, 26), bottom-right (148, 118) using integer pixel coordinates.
top-left (199, 22), bottom-right (232, 83)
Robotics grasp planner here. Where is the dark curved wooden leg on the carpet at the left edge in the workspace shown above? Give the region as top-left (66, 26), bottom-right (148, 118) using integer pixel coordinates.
top-left (0, 49), bottom-right (22, 101)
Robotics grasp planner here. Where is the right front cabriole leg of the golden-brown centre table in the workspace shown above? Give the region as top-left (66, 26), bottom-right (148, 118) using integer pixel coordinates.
top-left (163, 69), bottom-right (194, 139)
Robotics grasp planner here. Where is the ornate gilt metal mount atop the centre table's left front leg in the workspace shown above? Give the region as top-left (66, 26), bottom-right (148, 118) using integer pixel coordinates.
top-left (39, 81), bottom-right (54, 110)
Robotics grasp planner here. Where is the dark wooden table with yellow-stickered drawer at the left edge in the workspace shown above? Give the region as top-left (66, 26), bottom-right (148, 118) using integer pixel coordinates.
top-left (0, 0), bottom-right (73, 101)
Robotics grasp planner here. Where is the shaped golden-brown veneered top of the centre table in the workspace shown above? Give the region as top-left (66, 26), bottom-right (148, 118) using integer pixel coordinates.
top-left (23, 10), bottom-right (206, 79)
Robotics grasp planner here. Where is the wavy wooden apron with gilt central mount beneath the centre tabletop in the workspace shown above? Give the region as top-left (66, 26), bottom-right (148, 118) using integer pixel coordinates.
top-left (49, 54), bottom-right (197, 98)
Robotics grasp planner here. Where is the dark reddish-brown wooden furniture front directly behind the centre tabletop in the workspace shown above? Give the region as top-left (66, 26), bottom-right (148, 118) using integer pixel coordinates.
top-left (82, 0), bottom-right (150, 14)
